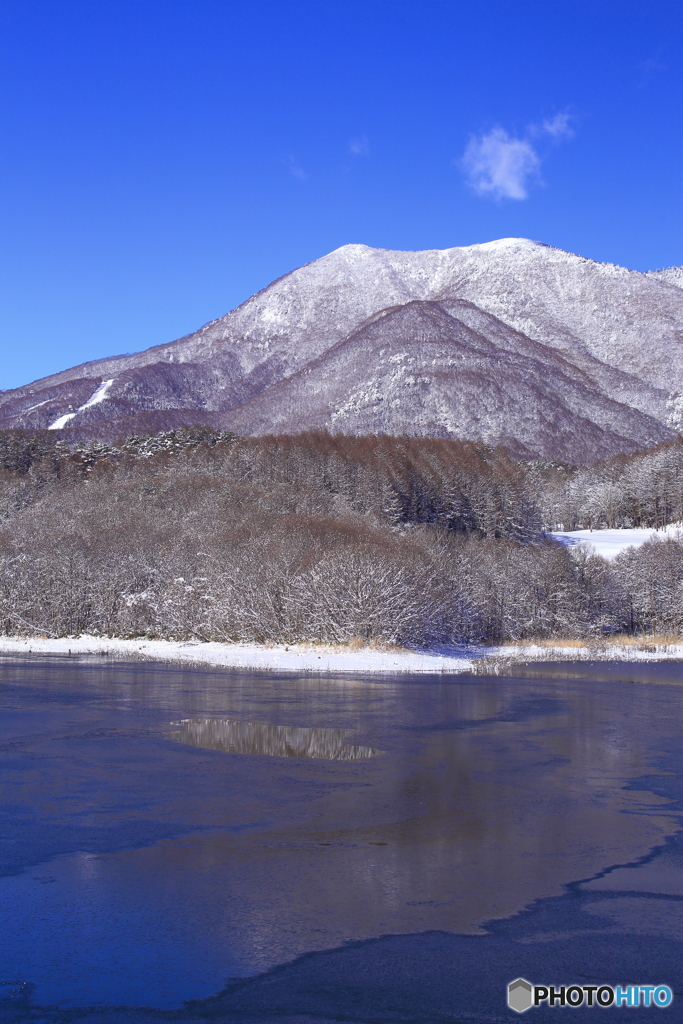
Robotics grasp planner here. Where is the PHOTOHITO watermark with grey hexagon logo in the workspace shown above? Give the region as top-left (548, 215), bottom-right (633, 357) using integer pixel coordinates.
top-left (508, 978), bottom-right (674, 1014)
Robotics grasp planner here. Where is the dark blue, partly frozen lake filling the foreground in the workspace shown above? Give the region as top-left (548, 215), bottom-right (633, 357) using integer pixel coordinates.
top-left (0, 657), bottom-right (683, 1024)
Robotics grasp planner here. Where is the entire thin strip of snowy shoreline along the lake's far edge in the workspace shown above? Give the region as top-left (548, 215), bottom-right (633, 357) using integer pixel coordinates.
top-left (0, 636), bottom-right (683, 675)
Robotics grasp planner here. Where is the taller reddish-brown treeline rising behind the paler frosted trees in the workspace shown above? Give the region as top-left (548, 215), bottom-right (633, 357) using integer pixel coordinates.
top-left (0, 427), bottom-right (543, 541)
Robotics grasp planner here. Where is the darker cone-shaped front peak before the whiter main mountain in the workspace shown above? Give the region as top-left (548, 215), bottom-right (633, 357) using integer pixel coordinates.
top-left (229, 301), bottom-right (668, 461)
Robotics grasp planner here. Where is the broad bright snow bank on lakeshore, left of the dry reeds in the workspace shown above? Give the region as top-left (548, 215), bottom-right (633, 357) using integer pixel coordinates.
top-left (0, 636), bottom-right (479, 674)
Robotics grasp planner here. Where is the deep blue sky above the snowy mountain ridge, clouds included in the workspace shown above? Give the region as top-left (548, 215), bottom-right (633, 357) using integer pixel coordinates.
top-left (0, 0), bottom-right (683, 388)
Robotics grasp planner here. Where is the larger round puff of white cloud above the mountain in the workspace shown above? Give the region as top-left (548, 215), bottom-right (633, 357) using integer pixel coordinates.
top-left (462, 128), bottom-right (541, 200)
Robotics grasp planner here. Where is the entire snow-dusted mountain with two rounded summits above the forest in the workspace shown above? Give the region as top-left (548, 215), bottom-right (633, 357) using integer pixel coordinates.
top-left (0, 239), bottom-right (683, 463)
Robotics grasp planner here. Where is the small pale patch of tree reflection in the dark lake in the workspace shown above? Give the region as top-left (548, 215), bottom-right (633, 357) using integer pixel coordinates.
top-left (170, 718), bottom-right (383, 761)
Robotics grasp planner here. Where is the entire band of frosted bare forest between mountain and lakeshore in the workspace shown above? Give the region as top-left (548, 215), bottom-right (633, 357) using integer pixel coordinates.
top-left (0, 427), bottom-right (683, 646)
